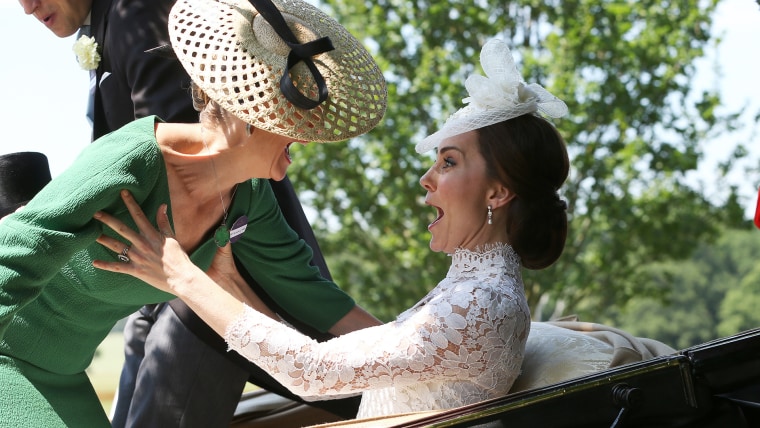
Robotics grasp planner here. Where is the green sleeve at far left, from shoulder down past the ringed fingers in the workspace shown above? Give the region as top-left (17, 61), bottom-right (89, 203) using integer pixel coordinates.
top-left (0, 118), bottom-right (165, 339)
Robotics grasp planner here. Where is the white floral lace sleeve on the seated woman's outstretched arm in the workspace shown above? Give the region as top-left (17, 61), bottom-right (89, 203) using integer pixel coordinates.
top-left (225, 280), bottom-right (529, 399)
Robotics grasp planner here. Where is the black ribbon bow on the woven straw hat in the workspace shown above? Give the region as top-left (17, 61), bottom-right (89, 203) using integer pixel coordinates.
top-left (249, 0), bottom-right (335, 110)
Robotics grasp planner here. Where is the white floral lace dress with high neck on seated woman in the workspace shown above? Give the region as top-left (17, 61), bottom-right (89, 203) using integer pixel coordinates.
top-left (225, 244), bottom-right (530, 418)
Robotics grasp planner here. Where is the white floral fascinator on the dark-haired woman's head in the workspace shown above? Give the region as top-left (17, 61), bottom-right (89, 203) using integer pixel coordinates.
top-left (415, 39), bottom-right (567, 153)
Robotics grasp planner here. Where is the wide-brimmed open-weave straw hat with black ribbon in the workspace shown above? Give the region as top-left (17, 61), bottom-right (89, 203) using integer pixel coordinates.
top-left (169, 0), bottom-right (387, 142)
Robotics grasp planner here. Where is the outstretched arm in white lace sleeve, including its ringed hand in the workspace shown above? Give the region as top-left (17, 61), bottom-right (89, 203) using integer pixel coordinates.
top-left (95, 192), bottom-right (529, 398)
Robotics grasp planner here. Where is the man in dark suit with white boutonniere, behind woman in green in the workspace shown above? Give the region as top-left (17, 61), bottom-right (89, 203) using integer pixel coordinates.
top-left (19, 0), bottom-right (358, 427)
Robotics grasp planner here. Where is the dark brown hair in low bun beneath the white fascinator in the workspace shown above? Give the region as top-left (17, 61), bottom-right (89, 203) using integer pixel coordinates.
top-left (477, 114), bottom-right (570, 269)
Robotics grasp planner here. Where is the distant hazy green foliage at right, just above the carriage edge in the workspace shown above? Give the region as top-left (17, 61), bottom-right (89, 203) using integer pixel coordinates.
top-left (603, 230), bottom-right (760, 349)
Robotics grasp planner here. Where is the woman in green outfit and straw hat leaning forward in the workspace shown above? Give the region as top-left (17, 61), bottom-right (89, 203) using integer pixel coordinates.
top-left (0, 0), bottom-right (385, 428)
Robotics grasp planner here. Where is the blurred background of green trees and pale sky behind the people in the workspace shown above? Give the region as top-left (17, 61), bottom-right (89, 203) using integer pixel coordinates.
top-left (0, 0), bottom-right (760, 414)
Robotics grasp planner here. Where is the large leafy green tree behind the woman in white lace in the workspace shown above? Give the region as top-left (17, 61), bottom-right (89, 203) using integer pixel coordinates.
top-left (290, 0), bottom-right (736, 319)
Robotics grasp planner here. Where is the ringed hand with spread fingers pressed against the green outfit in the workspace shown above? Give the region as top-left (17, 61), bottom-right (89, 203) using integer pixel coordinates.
top-left (92, 190), bottom-right (197, 295)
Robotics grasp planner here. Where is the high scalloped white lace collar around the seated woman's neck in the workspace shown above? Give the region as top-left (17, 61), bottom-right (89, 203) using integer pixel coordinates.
top-left (447, 242), bottom-right (521, 276)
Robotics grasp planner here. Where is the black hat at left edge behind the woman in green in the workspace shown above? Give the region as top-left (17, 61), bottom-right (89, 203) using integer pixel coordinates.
top-left (0, 152), bottom-right (51, 217)
